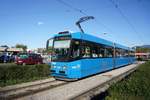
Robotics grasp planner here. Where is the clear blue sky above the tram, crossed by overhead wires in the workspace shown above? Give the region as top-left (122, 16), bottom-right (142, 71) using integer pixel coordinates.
top-left (0, 0), bottom-right (150, 49)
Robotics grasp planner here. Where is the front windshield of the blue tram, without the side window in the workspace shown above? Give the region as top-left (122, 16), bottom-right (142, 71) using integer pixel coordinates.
top-left (52, 40), bottom-right (71, 61)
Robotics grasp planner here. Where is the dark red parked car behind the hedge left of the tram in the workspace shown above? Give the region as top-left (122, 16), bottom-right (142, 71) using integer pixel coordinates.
top-left (15, 53), bottom-right (43, 65)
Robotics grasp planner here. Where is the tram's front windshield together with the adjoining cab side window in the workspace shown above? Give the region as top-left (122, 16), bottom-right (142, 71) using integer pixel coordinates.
top-left (49, 39), bottom-right (80, 62)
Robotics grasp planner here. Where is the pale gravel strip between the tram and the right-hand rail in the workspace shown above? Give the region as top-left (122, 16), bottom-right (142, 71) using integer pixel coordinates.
top-left (17, 63), bottom-right (144, 100)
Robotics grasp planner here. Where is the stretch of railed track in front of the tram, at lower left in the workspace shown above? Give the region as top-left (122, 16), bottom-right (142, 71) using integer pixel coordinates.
top-left (0, 79), bottom-right (68, 100)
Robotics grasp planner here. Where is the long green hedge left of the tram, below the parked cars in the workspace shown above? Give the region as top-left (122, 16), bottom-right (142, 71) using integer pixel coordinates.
top-left (0, 64), bottom-right (50, 86)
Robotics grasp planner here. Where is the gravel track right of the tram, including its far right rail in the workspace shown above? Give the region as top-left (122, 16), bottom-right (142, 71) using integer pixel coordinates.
top-left (14, 63), bottom-right (141, 100)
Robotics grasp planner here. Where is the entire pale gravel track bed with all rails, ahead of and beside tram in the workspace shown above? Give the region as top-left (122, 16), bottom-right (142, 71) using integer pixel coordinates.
top-left (0, 62), bottom-right (143, 100)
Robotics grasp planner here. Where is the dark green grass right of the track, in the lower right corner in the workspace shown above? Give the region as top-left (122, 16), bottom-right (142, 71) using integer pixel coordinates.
top-left (105, 61), bottom-right (150, 100)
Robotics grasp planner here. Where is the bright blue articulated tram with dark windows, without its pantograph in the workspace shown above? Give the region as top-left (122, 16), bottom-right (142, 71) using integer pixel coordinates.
top-left (47, 31), bottom-right (135, 80)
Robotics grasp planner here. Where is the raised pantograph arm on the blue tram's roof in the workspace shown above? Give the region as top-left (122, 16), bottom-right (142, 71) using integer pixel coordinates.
top-left (76, 16), bottom-right (94, 33)
